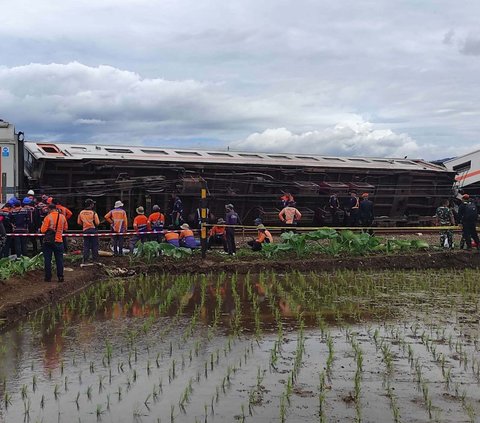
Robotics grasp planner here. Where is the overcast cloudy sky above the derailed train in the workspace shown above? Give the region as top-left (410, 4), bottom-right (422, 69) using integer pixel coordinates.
top-left (0, 0), bottom-right (480, 159)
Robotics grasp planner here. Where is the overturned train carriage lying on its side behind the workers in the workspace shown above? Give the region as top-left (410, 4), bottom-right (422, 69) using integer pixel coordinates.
top-left (24, 142), bottom-right (454, 229)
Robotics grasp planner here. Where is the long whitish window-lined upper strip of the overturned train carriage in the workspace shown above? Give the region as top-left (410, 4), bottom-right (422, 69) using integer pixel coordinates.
top-left (25, 142), bottom-right (448, 172)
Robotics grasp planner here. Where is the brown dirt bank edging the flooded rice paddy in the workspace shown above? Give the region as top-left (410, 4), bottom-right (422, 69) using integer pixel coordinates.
top-left (0, 251), bottom-right (480, 330)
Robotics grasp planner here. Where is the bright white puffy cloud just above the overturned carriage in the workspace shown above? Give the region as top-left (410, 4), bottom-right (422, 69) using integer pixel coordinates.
top-left (234, 121), bottom-right (421, 157)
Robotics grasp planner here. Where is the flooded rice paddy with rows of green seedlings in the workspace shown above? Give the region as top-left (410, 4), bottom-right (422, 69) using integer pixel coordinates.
top-left (0, 270), bottom-right (480, 423)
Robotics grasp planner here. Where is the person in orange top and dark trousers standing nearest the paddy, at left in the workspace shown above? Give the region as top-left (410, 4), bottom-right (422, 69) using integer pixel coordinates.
top-left (40, 202), bottom-right (68, 282)
